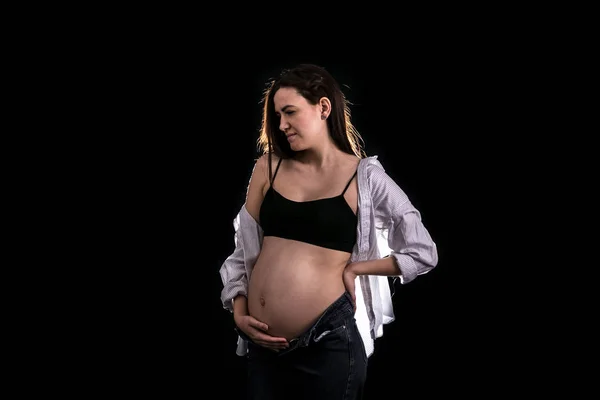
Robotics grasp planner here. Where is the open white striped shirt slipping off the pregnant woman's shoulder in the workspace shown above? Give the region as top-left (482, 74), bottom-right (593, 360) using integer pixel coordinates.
top-left (219, 156), bottom-right (438, 356)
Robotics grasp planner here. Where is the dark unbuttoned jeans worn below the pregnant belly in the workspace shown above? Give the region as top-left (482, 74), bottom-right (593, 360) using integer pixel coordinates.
top-left (244, 292), bottom-right (367, 400)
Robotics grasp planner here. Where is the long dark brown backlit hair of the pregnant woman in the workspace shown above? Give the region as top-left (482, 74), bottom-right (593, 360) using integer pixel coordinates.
top-left (257, 64), bottom-right (366, 180)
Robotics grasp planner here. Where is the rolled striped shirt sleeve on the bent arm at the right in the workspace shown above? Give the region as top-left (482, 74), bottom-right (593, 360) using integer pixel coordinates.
top-left (369, 163), bottom-right (438, 284)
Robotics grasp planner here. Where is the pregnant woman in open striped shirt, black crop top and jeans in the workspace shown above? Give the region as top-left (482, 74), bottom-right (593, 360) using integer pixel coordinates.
top-left (220, 64), bottom-right (437, 400)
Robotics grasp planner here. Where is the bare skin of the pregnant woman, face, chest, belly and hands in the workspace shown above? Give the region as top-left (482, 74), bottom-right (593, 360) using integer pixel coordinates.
top-left (234, 87), bottom-right (399, 351)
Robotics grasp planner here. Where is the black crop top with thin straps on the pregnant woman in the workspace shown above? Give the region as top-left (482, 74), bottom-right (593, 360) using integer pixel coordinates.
top-left (260, 159), bottom-right (358, 253)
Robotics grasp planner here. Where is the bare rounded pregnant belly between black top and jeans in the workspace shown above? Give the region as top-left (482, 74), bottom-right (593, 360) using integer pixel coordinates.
top-left (248, 236), bottom-right (350, 340)
